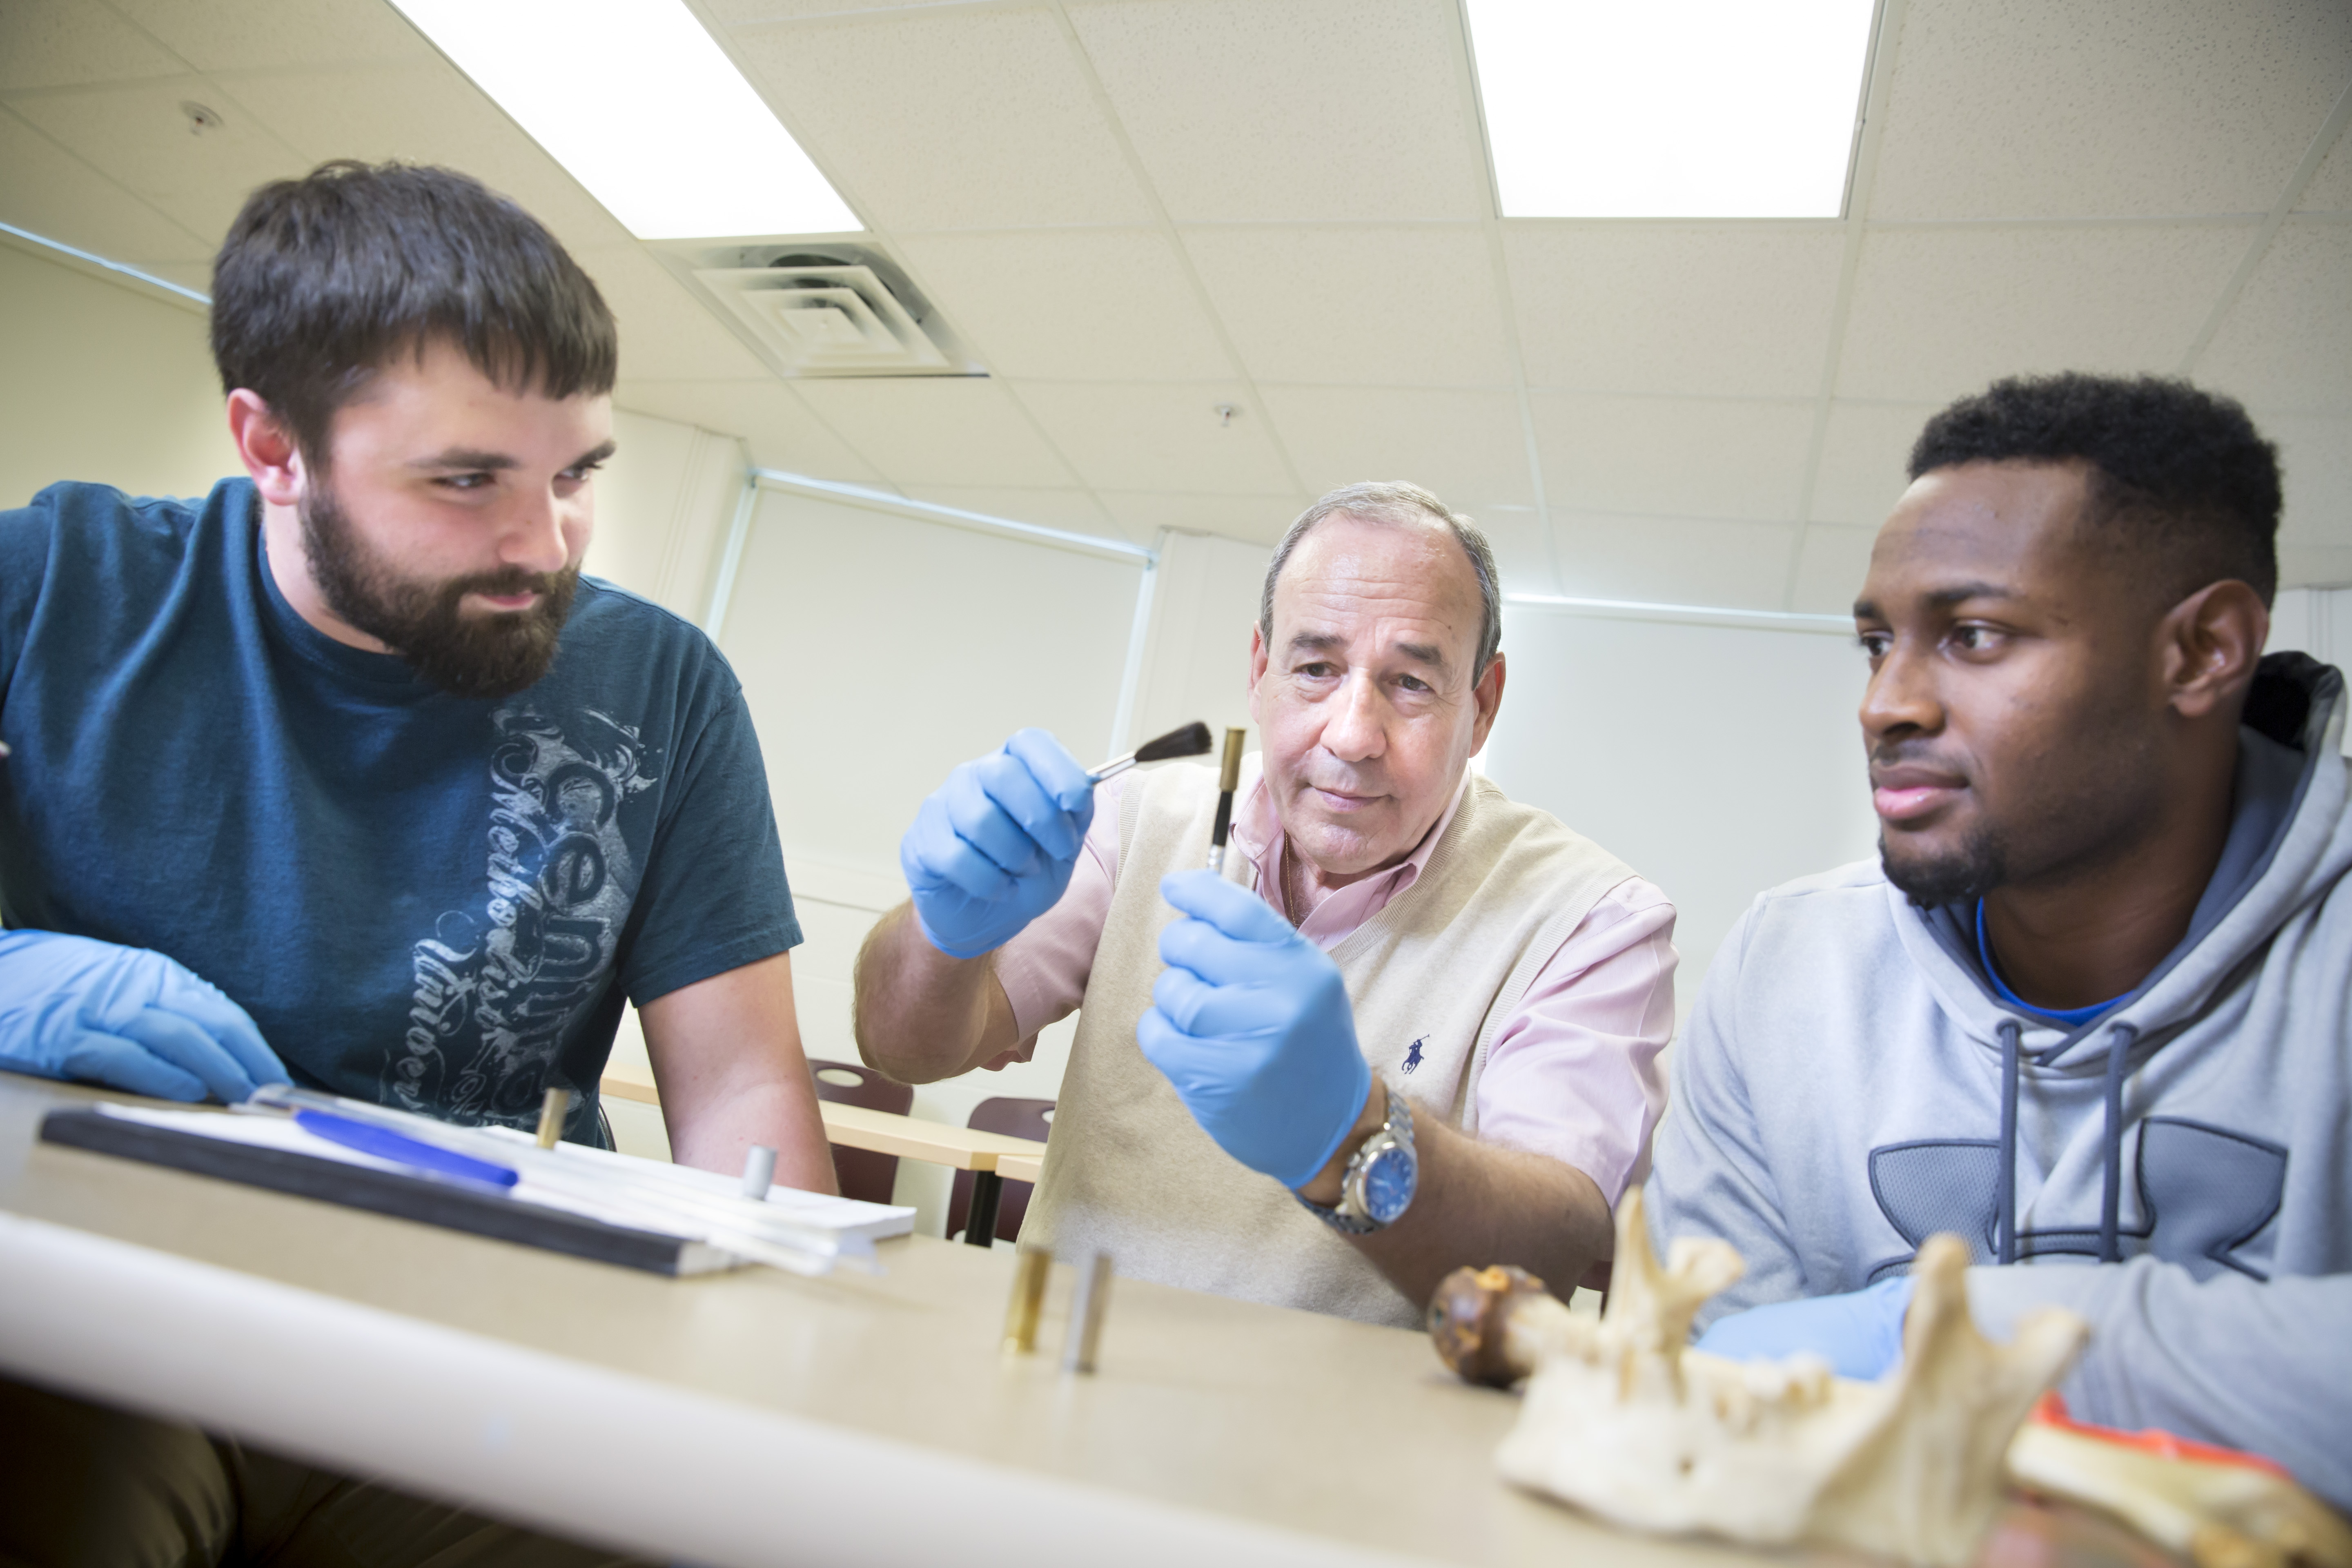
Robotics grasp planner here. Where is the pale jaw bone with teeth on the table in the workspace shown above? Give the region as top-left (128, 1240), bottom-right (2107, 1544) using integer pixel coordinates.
top-left (1430, 1189), bottom-right (2089, 1568)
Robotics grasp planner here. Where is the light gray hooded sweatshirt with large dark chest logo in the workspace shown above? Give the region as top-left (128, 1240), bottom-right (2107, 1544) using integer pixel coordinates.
top-left (1649, 653), bottom-right (2352, 1507)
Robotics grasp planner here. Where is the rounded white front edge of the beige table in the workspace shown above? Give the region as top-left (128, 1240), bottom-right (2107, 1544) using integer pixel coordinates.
top-left (0, 1211), bottom-right (1399, 1568)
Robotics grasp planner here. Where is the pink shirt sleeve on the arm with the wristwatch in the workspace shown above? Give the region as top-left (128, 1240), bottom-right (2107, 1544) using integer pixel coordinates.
top-left (1477, 877), bottom-right (1677, 1208)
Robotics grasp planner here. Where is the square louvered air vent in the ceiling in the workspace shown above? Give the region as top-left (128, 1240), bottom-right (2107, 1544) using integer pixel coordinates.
top-left (663, 242), bottom-right (988, 379)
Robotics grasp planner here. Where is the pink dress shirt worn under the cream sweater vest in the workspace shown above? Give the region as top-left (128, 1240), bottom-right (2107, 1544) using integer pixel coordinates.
top-left (990, 755), bottom-right (1677, 1206)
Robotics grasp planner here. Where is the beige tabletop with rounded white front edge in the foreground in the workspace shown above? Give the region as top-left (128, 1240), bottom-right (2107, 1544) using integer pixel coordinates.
top-left (0, 1072), bottom-right (2164, 1568)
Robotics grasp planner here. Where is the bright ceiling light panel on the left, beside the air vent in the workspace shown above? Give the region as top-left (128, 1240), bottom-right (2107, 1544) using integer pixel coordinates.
top-left (393, 0), bottom-right (861, 240)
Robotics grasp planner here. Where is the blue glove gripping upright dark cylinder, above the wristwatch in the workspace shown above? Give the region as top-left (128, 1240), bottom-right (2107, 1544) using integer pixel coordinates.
top-left (1136, 872), bottom-right (1371, 1187)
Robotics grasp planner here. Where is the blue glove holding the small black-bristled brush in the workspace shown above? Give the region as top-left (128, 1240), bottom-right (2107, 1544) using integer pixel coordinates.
top-left (898, 729), bottom-right (1094, 959)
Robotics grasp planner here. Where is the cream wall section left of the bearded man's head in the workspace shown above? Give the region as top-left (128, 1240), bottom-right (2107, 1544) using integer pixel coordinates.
top-left (0, 235), bottom-right (242, 510)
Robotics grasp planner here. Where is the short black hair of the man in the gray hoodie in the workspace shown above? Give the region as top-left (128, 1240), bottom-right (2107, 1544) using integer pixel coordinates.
top-left (1910, 372), bottom-right (2279, 604)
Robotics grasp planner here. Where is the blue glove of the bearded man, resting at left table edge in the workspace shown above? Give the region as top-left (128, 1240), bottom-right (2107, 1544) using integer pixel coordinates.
top-left (0, 931), bottom-right (289, 1102)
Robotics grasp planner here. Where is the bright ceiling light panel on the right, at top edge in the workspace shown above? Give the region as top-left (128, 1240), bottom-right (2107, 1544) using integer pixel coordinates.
top-left (1465, 0), bottom-right (1875, 218)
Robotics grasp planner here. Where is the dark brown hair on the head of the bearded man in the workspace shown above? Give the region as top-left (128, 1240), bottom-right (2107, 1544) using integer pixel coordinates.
top-left (212, 160), bottom-right (621, 470)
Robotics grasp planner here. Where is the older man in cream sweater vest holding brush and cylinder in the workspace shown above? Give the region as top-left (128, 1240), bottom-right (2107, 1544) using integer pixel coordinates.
top-left (856, 484), bottom-right (1675, 1323)
